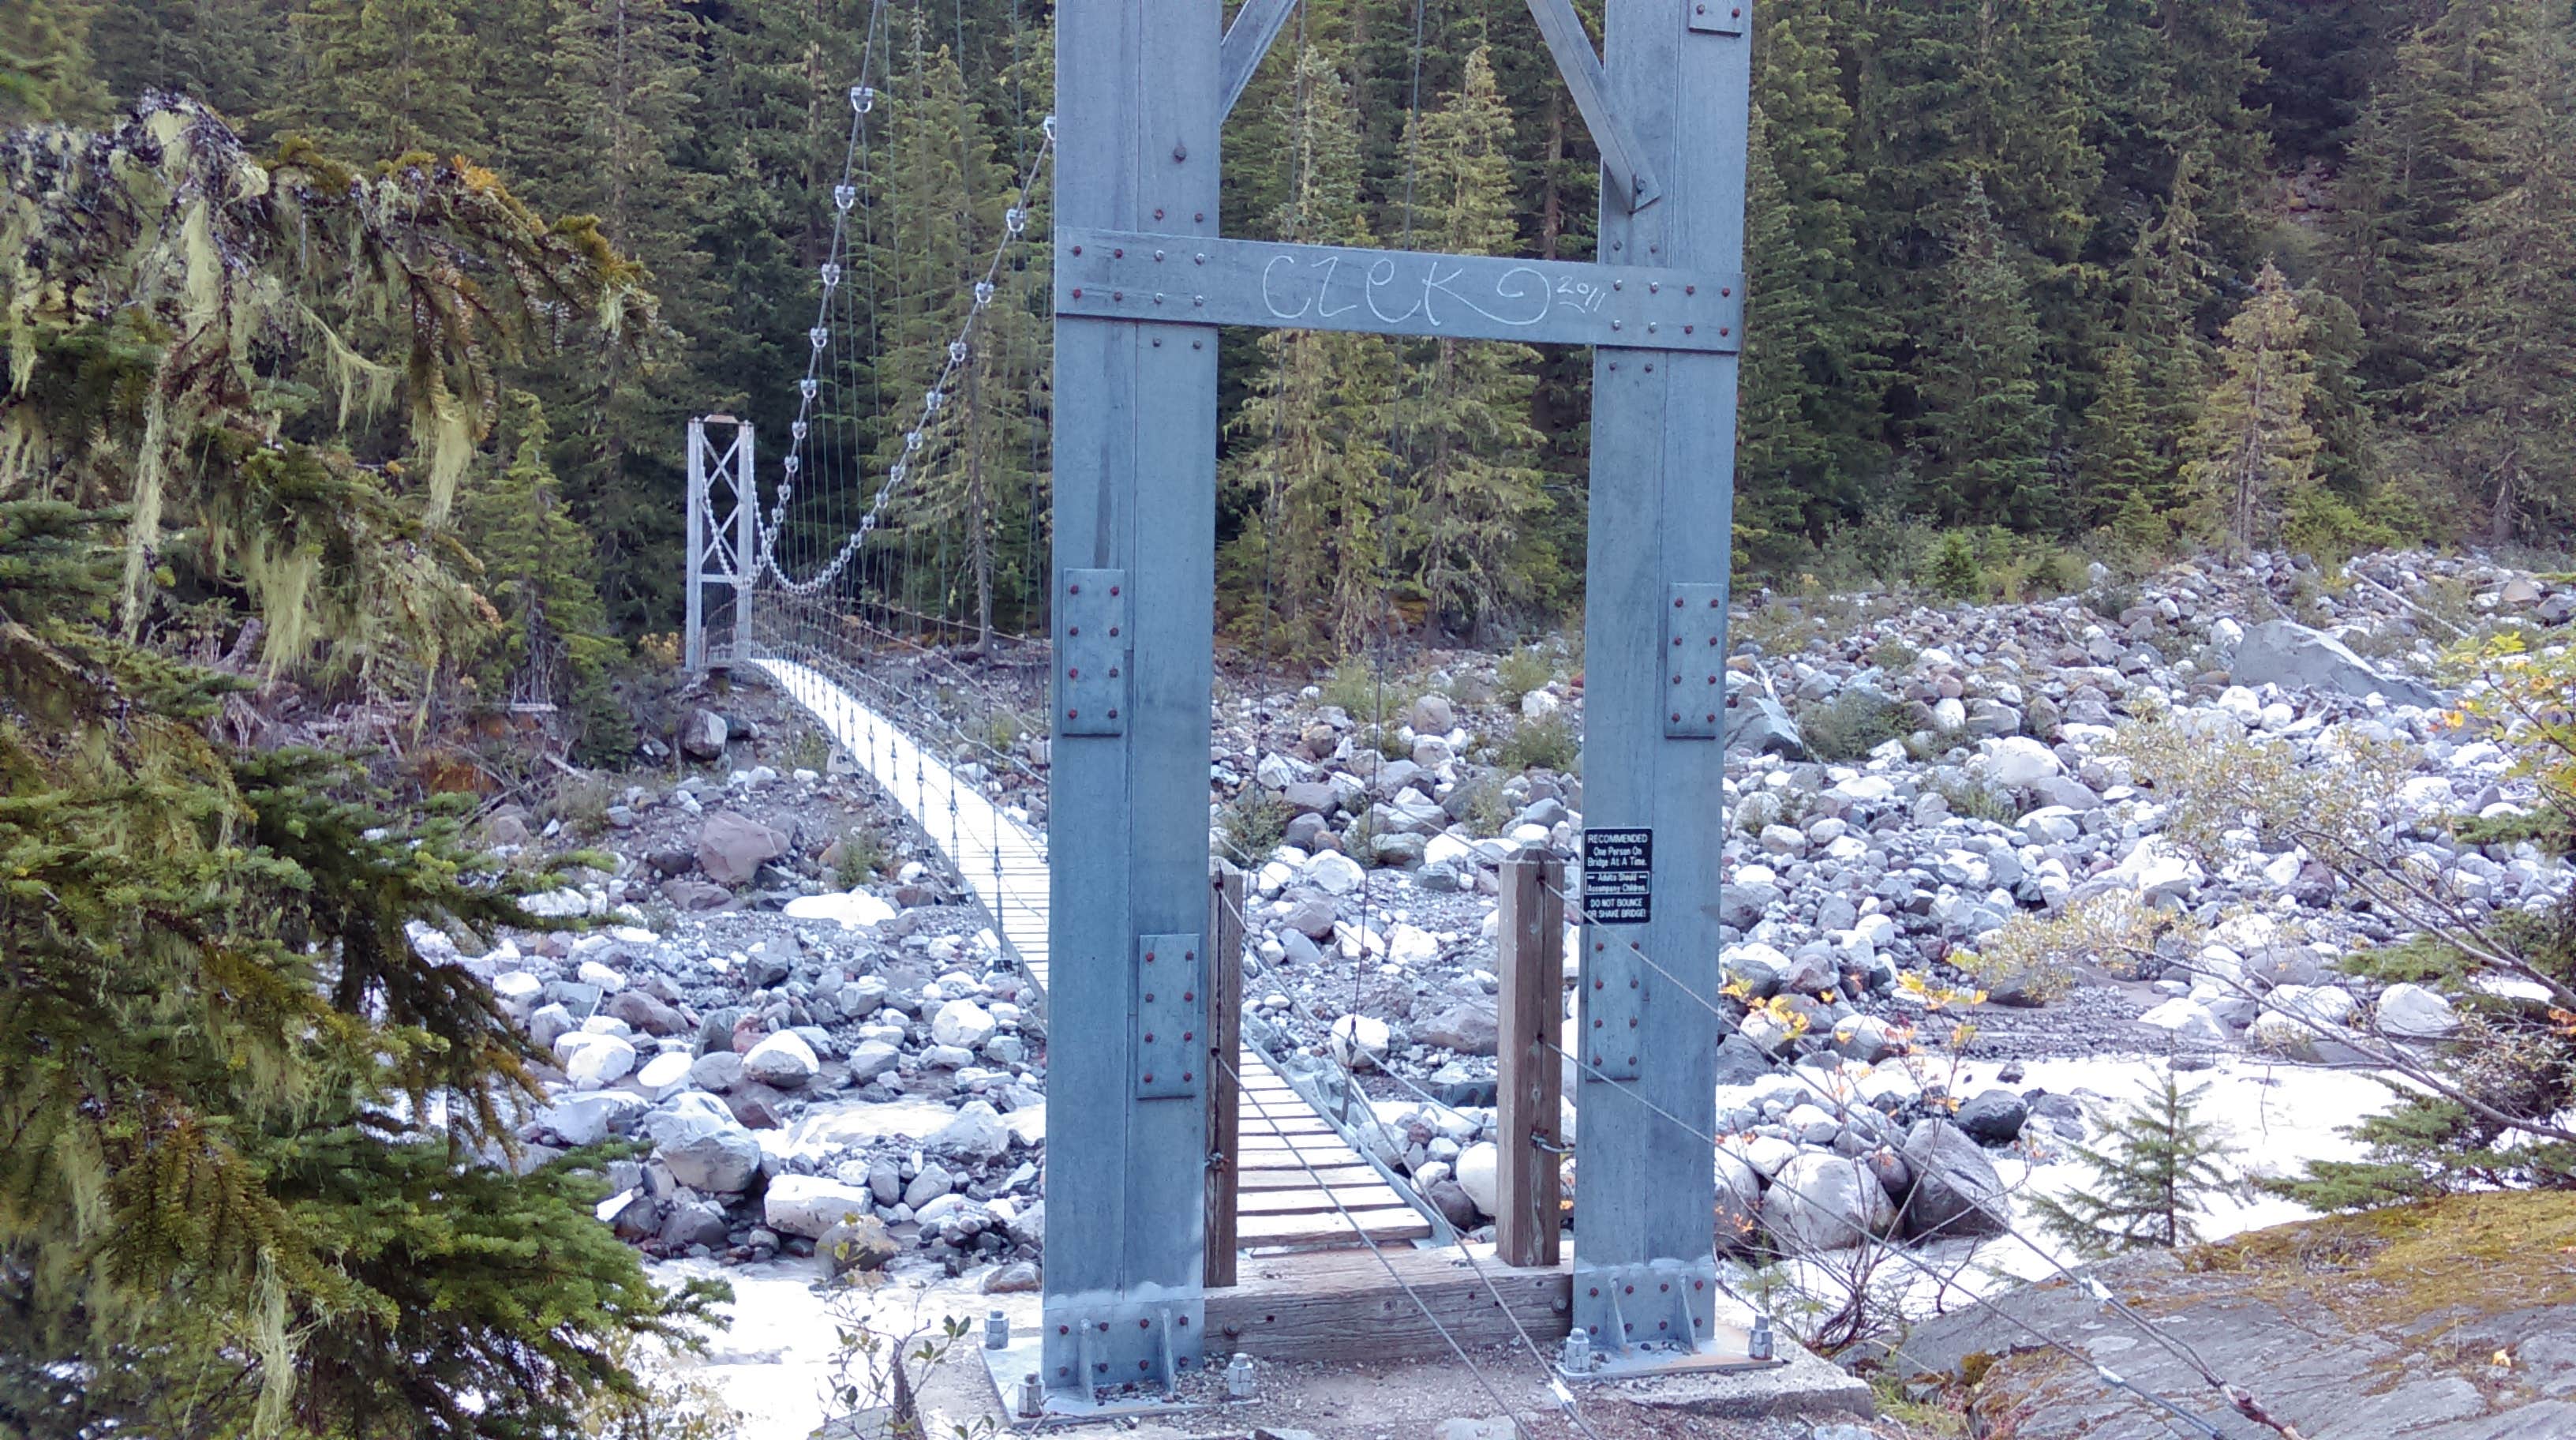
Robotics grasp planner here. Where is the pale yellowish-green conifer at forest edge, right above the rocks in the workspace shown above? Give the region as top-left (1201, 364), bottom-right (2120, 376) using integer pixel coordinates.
top-left (2182, 263), bottom-right (2319, 551)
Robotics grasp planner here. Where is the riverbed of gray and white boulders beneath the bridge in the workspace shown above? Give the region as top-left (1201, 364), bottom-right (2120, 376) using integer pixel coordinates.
top-left (422, 557), bottom-right (2576, 1432)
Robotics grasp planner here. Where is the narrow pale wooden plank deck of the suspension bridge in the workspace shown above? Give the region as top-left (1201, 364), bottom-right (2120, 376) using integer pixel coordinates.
top-left (750, 659), bottom-right (1432, 1250)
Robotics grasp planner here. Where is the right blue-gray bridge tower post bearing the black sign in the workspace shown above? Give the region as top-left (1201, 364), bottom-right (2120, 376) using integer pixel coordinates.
top-left (1574, 0), bottom-right (1752, 1352)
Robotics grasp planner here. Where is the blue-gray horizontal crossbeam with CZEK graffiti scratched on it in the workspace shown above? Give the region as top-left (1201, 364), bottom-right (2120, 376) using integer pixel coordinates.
top-left (1056, 227), bottom-right (1744, 353)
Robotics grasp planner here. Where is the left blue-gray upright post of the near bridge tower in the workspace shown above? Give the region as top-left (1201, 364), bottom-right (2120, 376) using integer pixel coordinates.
top-left (1043, 0), bottom-right (1223, 1393)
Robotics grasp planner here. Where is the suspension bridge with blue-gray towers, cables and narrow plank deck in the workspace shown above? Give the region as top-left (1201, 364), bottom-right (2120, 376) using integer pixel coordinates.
top-left (685, 0), bottom-right (1759, 1414)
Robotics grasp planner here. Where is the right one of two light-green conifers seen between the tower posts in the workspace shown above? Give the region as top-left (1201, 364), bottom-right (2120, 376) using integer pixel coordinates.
top-left (1391, 47), bottom-right (1553, 634)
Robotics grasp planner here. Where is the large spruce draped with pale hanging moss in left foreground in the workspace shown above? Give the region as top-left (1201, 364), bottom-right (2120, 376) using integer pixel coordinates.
top-left (0, 98), bottom-right (703, 1440)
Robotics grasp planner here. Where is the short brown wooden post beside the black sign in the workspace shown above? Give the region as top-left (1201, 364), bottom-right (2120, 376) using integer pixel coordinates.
top-left (1494, 850), bottom-right (1567, 1267)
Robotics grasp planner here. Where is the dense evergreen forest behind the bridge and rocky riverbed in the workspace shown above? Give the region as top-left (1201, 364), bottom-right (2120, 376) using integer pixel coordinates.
top-left (8, 0), bottom-right (2576, 659)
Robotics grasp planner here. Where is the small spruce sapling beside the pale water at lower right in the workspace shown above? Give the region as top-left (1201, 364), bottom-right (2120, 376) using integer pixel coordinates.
top-left (2032, 1069), bottom-right (2228, 1257)
